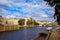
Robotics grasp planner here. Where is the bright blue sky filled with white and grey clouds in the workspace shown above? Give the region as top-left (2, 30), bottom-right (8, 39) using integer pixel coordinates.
top-left (0, 0), bottom-right (54, 22)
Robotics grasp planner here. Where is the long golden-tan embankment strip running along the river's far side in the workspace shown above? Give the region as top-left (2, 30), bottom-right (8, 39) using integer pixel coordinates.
top-left (0, 25), bottom-right (57, 32)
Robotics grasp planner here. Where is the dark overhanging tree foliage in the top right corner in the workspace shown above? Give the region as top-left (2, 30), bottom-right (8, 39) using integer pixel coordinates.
top-left (44, 0), bottom-right (60, 25)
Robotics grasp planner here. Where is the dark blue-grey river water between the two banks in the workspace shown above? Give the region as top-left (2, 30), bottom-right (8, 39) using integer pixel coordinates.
top-left (0, 27), bottom-right (55, 40)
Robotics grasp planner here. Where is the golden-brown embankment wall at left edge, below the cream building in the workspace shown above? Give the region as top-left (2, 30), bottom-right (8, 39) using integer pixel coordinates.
top-left (0, 25), bottom-right (19, 32)
